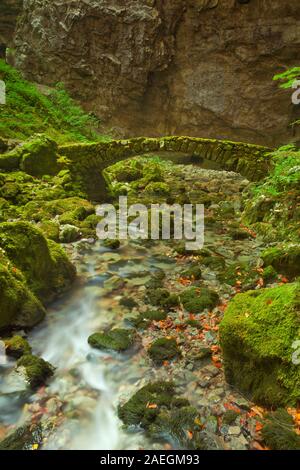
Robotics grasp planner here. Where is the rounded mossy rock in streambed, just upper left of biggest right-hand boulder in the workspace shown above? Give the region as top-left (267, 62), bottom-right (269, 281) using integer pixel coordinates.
top-left (180, 287), bottom-right (219, 313)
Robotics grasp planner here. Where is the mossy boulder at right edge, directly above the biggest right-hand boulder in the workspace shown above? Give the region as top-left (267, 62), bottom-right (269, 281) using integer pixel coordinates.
top-left (261, 243), bottom-right (300, 276)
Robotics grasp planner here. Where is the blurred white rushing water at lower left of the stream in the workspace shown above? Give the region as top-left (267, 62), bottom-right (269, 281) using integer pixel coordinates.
top-left (25, 250), bottom-right (149, 450)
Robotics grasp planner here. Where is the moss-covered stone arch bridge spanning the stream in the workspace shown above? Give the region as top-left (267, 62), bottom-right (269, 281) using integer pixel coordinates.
top-left (59, 137), bottom-right (271, 201)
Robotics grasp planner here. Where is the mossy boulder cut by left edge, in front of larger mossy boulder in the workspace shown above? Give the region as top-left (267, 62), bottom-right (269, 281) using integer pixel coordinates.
top-left (0, 252), bottom-right (45, 330)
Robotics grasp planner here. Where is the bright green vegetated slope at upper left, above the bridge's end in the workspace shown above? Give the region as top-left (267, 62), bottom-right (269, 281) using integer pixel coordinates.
top-left (0, 60), bottom-right (108, 143)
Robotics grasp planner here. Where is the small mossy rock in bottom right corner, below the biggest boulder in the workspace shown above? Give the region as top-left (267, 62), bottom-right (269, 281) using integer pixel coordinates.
top-left (261, 409), bottom-right (300, 450)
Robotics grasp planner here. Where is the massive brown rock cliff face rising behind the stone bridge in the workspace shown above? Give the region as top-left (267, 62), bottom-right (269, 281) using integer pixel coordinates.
top-left (4, 0), bottom-right (300, 145)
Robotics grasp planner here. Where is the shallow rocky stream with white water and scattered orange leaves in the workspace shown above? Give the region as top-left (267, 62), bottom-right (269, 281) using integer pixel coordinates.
top-left (0, 165), bottom-right (259, 450)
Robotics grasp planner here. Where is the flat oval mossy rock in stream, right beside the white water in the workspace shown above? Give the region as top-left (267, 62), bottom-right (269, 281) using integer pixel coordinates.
top-left (88, 328), bottom-right (135, 352)
